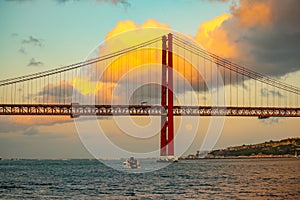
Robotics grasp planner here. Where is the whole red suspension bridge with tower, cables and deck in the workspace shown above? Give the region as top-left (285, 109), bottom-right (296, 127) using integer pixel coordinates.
top-left (0, 33), bottom-right (300, 155)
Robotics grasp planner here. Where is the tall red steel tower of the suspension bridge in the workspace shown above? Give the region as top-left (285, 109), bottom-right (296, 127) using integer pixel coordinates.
top-left (160, 33), bottom-right (174, 156)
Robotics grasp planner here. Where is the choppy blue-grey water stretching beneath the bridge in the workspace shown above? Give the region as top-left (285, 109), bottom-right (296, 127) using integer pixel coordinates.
top-left (0, 159), bottom-right (300, 199)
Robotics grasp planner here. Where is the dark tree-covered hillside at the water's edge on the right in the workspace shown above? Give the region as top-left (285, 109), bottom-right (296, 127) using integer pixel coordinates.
top-left (205, 138), bottom-right (300, 158)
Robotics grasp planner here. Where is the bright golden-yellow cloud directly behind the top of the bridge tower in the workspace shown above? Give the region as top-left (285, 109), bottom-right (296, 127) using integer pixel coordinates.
top-left (72, 19), bottom-right (214, 103)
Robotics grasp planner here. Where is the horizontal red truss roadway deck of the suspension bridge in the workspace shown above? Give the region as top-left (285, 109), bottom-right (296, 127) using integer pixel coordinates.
top-left (0, 103), bottom-right (300, 118)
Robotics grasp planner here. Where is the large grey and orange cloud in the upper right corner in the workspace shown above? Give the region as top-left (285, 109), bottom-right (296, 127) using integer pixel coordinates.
top-left (196, 0), bottom-right (300, 76)
